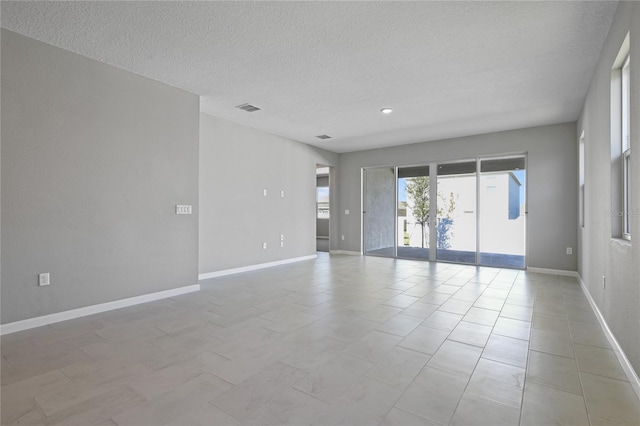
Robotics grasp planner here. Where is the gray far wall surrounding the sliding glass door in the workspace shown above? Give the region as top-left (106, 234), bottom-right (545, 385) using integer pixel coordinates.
top-left (338, 123), bottom-right (578, 271)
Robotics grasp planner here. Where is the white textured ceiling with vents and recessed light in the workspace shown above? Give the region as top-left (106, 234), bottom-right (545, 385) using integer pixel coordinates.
top-left (1, 1), bottom-right (617, 152)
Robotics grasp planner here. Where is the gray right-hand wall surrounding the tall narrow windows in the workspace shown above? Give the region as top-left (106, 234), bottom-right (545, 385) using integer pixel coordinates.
top-left (575, 2), bottom-right (640, 373)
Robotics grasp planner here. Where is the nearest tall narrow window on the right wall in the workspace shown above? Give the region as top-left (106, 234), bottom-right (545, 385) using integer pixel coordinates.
top-left (620, 55), bottom-right (631, 240)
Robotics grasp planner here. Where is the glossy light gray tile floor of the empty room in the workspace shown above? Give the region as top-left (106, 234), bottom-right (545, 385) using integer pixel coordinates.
top-left (1, 254), bottom-right (640, 426)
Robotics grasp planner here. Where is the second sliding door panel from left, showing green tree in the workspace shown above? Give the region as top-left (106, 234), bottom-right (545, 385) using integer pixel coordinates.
top-left (396, 166), bottom-right (431, 260)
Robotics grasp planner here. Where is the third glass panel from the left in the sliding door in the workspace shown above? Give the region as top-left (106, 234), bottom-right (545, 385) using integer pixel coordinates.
top-left (435, 161), bottom-right (477, 265)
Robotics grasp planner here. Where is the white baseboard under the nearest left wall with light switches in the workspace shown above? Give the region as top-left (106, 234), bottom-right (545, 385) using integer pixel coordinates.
top-left (0, 284), bottom-right (200, 336)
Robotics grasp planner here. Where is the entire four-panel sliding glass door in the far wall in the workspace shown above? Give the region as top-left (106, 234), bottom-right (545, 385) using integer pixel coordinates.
top-left (362, 155), bottom-right (526, 269)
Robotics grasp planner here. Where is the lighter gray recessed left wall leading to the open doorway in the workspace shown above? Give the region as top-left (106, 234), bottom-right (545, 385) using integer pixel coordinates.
top-left (199, 114), bottom-right (338, 274)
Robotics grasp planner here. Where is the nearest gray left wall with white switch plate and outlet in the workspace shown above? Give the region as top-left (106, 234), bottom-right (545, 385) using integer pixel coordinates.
top-left (1, 30), bottom-right (199, 323)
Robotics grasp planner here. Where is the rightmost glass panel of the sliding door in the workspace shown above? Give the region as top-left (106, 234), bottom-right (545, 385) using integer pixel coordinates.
top-left (478, 157), bottom-right (526, 269)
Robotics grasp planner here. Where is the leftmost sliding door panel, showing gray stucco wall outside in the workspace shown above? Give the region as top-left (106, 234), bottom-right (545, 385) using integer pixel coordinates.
top-left (362, 167), bottom-right (396, 257)
